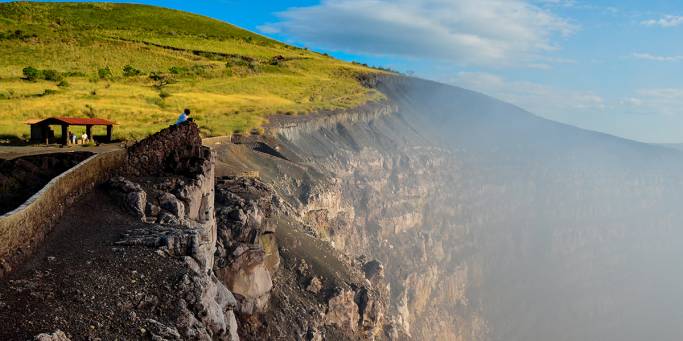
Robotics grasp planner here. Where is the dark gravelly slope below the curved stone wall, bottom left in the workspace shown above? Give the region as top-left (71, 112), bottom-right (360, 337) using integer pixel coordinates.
top-left (0, 190), bottom-right (183, 340)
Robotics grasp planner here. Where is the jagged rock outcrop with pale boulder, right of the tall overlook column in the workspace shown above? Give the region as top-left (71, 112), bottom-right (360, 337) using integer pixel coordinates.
top-left (214, 177), bottom-right (284, 314)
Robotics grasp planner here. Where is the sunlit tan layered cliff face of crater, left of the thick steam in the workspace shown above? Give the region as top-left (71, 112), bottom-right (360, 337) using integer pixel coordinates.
top-left (217, 97), bottom-right (487, 340)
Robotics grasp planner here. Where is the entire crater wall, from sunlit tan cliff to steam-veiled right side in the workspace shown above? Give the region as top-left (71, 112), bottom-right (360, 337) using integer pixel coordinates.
top-left (216, 78), bottom-right (683, 340)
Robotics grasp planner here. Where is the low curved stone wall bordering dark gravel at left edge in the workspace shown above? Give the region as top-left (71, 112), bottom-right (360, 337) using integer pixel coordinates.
top-left (0, 150), bottom-right (126, 278)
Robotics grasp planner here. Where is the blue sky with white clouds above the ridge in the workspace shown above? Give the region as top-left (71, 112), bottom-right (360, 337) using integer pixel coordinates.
top-left (14, 0), bottom-right (683, 143)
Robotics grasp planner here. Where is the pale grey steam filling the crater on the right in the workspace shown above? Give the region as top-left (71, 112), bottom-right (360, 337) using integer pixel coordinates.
top-left (380, 77), bottom-right (683, 340)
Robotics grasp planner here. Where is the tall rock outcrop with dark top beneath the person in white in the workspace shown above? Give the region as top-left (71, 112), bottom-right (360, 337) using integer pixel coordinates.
top-left (108, 123), bottom-right (239, 340)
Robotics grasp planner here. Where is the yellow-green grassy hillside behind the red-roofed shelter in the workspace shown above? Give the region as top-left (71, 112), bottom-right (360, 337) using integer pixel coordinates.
top-left (0, 2), bottom-right (382, 138)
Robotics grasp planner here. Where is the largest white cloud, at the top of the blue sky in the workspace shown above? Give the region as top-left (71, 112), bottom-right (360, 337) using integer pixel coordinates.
top-left (260, 0), bottom-right (576, 66)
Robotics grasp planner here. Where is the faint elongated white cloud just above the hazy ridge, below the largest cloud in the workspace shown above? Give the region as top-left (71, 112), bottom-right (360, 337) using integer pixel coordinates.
top-left (449, 72), bottom-right (607, 116)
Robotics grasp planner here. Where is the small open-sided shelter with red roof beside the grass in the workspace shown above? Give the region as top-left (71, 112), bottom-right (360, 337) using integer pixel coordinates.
top-left (26, 117), bottom-right (116, 144)
